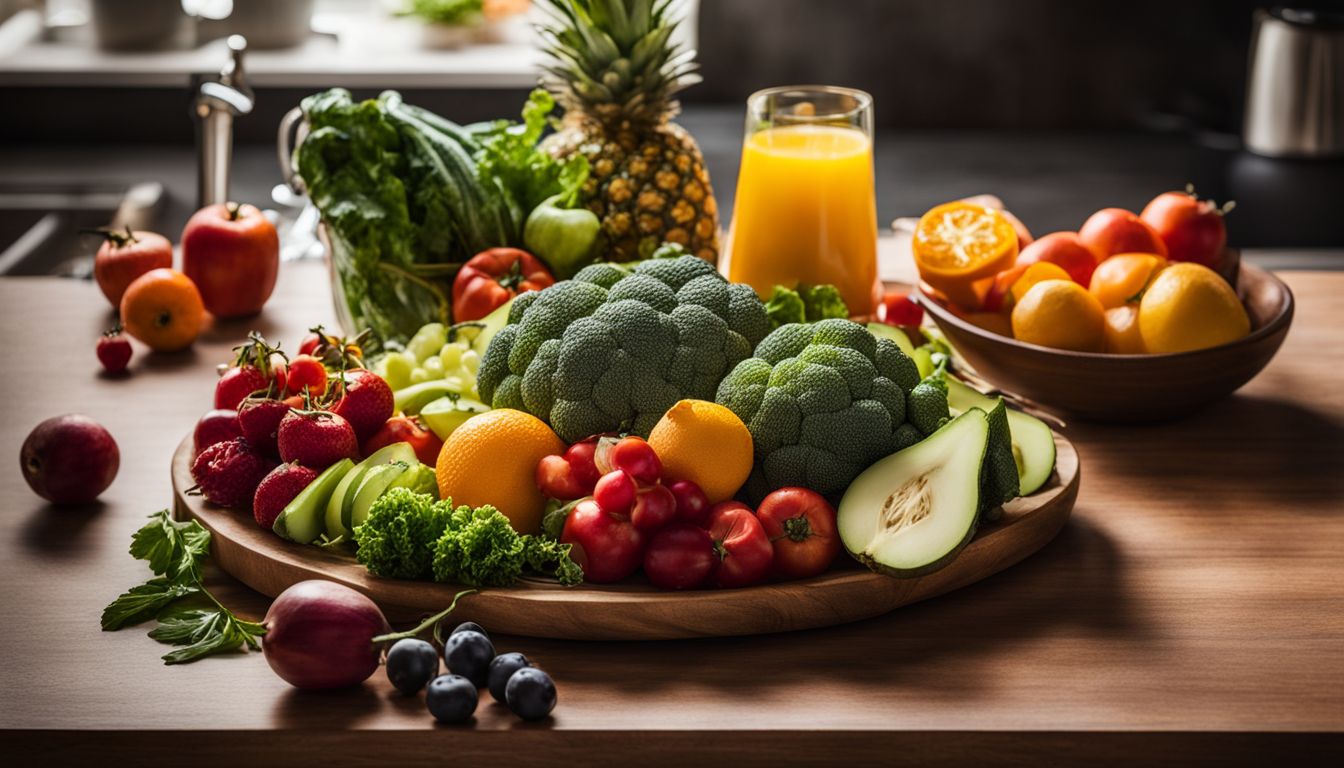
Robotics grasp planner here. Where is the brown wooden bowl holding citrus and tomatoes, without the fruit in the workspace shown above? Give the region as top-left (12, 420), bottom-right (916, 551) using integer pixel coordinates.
top-left (919, 264), bottom-right (1293, 422)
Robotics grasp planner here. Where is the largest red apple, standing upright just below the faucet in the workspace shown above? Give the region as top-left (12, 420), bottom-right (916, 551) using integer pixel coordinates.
top-left (181, 203), bottom-right (280, 317)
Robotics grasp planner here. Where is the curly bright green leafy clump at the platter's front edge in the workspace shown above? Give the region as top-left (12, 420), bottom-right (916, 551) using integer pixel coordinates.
top-left (355, 488), bottom-right (583, 586)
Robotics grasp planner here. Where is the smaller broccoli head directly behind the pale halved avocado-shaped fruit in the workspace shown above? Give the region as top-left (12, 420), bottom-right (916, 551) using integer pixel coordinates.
top-left (716, 320), bottom-right (948, 502)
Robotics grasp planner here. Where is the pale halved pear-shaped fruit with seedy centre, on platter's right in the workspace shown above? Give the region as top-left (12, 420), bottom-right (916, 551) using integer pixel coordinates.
top-left (836, 409), bottom-right (989, 578)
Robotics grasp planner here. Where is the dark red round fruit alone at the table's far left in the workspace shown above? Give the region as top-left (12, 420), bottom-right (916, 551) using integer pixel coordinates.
top-left (19, 413), bottom-right (121, 504)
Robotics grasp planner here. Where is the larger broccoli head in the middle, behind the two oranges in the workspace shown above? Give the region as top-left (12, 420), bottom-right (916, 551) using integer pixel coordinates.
top-left (477, 256), bottom-right (768, 443)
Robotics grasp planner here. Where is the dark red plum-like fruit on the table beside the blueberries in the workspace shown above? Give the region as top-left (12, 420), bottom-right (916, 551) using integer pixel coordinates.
top-left (261, 580), bottom-right (391, 690)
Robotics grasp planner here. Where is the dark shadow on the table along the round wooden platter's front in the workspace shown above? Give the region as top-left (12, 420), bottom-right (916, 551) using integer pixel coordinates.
top-left (513, 515), bottom-right (1144, 701)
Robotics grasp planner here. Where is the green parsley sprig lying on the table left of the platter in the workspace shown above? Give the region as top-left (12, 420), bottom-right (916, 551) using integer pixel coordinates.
top-left (102, 510), bottom-right (266, 664)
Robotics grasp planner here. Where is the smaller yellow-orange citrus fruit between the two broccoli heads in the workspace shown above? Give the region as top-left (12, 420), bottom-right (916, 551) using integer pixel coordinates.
top-left (649, 399), bottom-right (753, 504)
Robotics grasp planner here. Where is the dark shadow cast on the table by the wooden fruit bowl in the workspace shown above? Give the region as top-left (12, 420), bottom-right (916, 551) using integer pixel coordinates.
top-left (1068, 395), bottom-right (1344, 515)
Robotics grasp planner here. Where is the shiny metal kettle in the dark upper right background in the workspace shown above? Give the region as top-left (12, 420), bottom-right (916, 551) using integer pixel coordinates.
top-left (1243, 8), bottom-right (1344, 157)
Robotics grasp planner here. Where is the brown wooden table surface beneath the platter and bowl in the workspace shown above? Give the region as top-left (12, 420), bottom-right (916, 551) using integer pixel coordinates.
top-left (0, 256), bottom-right (1344, 765)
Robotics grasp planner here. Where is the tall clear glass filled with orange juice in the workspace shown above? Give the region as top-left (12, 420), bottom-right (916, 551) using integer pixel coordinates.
top-left (727, 86), bottom-right (882, 315)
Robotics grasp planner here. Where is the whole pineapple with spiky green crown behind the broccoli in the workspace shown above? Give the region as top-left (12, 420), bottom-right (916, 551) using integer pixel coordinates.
top-left (539, 0), bottom-right (719, 262)
